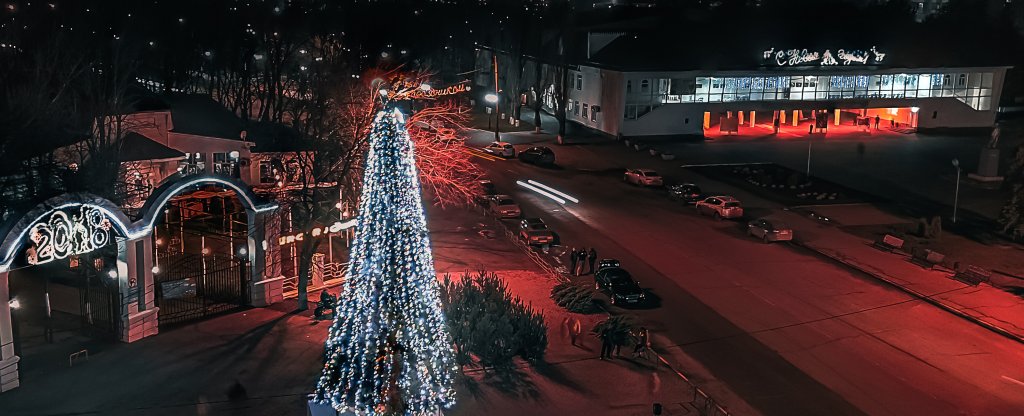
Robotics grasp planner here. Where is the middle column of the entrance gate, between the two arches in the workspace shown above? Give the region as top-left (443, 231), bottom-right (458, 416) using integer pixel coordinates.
top-left (117, 235), bottom-right (160, 342)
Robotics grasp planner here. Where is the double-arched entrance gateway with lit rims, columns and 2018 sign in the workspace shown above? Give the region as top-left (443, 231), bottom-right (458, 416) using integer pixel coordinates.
top-left (0, 174), bottom-right (282, 391)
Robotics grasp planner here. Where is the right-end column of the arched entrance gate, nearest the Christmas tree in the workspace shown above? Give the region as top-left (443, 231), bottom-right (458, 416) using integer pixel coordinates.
top-left (243, 210), bottom-right (285, 306)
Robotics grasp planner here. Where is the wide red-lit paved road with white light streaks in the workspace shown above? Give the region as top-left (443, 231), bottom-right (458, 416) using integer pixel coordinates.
top-left (469, 128), bottom-right (1024, 415)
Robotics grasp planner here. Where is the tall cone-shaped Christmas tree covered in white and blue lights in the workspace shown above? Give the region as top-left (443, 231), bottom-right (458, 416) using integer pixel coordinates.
top-left (315, 105), bottom-right (457, 415)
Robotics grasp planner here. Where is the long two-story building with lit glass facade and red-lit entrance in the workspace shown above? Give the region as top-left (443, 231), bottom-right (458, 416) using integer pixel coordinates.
top-left (542, 33), bottom-right (1009, 137)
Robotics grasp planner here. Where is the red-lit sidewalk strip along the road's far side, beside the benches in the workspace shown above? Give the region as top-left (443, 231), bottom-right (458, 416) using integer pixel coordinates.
top-left (773, 211), bottom-right (1024, 342)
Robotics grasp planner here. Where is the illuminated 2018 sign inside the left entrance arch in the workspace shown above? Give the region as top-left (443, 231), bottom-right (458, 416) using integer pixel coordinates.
top-left (27, 205), bottom-right (111, 264)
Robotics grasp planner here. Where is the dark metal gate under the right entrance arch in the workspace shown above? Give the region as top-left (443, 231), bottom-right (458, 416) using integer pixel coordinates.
top-left (155, 253), bottom-right (250, 327)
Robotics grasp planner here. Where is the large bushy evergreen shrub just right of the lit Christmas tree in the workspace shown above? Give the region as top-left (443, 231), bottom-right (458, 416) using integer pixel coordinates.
top-left (440, 272), bottom-right (548, 368)
